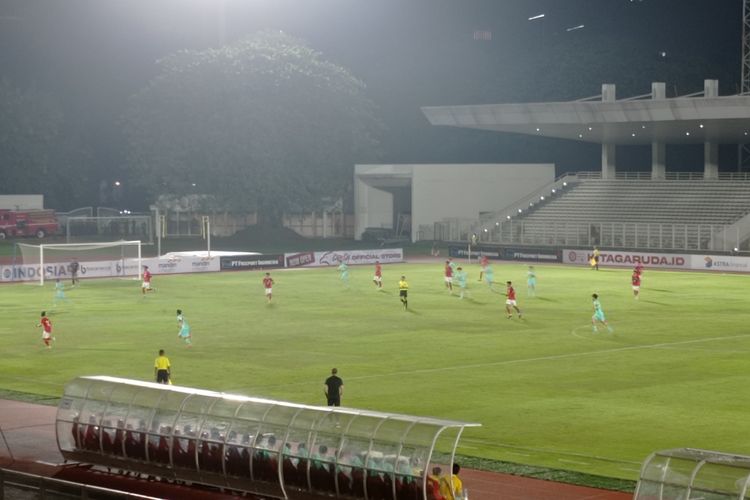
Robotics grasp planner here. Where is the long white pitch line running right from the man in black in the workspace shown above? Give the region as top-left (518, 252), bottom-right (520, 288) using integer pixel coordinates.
top-left (349, 334), bottom-right (750, 380)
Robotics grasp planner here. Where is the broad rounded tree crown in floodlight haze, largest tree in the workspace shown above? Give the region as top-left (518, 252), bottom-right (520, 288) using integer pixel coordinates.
top-left (124, 32), bottom-right (380, 221)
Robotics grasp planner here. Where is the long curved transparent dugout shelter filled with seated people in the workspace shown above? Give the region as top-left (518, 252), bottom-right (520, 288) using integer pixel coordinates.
top-left (56, 376), bottom-right (480, 500)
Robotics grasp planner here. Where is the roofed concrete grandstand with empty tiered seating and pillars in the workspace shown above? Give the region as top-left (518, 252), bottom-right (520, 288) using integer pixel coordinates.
top-left (423, 80), bottom-right (750, 252)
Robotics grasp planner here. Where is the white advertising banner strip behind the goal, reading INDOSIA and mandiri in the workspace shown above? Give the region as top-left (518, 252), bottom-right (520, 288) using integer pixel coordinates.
top-left (0, 257), bottom-right (219, 281)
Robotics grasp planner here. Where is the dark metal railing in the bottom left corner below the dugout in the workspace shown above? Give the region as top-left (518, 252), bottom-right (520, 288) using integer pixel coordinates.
top-left (0, 469), bottom-right (156, 500)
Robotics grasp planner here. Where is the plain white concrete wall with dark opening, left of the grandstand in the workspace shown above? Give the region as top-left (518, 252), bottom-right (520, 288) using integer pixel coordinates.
top-left (354, 164), bottom-right (555, 241)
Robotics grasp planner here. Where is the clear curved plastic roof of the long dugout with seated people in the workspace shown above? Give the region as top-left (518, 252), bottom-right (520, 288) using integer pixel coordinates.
top-left (56, 376), bottom-right (481, 490)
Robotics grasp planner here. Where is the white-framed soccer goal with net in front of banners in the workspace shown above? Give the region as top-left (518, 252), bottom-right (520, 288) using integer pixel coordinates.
top-left (14, 241), bottom-right (142, 285)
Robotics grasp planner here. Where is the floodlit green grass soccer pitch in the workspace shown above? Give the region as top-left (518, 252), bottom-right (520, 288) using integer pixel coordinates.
top-left (0, 262), bottom-right (750, 479)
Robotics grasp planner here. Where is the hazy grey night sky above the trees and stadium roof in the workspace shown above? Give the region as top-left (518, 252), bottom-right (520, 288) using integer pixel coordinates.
top-left (0, 0), bottom-right (742, 185)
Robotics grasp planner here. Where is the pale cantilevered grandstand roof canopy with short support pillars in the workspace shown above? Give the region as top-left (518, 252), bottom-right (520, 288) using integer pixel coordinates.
top-left (422, 80), bottom-right (750, 177)
